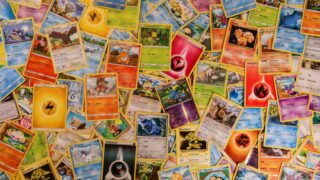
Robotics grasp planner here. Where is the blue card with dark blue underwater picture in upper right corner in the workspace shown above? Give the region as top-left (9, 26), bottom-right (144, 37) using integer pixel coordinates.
top-left (273, 4), bottom-right (306, 54)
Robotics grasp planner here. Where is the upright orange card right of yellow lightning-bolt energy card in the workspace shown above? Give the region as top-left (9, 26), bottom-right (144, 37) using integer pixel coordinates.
top-left (84, 73), bottom-right (119, 121)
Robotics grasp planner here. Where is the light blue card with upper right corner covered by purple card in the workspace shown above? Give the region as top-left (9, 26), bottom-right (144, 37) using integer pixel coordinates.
top-left (264, 100), bottom-right (299, 149)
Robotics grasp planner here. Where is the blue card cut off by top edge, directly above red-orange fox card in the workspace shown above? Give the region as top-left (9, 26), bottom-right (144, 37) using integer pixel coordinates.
top-left (221, 0), bottom-right (257, 18)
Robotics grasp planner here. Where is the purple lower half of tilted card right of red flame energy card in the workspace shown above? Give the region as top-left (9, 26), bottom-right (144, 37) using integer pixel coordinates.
top-left (279, 95), bottom-right (312, 122)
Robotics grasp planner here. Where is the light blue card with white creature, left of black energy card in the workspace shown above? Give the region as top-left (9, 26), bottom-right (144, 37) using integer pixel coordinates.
top-left (70, 139), bottom-right (102, 179)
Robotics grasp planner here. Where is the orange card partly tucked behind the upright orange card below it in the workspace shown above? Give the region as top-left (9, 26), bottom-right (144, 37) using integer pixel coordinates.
top-left (106, 41), bottom-right (141, 89)
